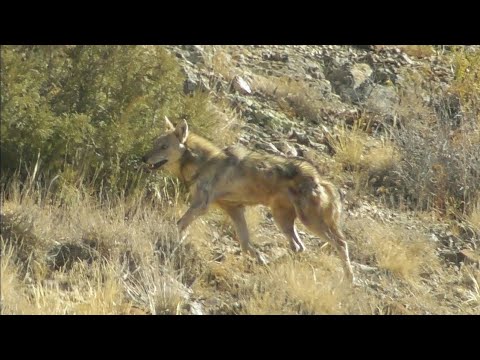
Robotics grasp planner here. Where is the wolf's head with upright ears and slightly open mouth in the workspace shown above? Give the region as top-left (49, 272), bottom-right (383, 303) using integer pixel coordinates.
top-left (142, 116), bottom-right (188, 170)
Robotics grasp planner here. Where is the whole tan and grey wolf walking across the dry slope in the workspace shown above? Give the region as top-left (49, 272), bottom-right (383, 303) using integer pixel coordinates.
top-left (142, 117), bottom-right (354, 281)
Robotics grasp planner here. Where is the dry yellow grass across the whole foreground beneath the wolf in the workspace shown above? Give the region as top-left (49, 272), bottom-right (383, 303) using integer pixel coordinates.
top-left (1, 181), bottom-right (479, 314)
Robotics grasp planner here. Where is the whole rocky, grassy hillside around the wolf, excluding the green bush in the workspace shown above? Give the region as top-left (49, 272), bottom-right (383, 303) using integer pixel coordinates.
top-left (2, 45), bottom-right (480, 314)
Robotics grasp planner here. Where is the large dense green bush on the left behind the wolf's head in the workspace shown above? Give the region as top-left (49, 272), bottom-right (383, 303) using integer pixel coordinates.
top-left (0, 45), bottom-right (208, 200)
